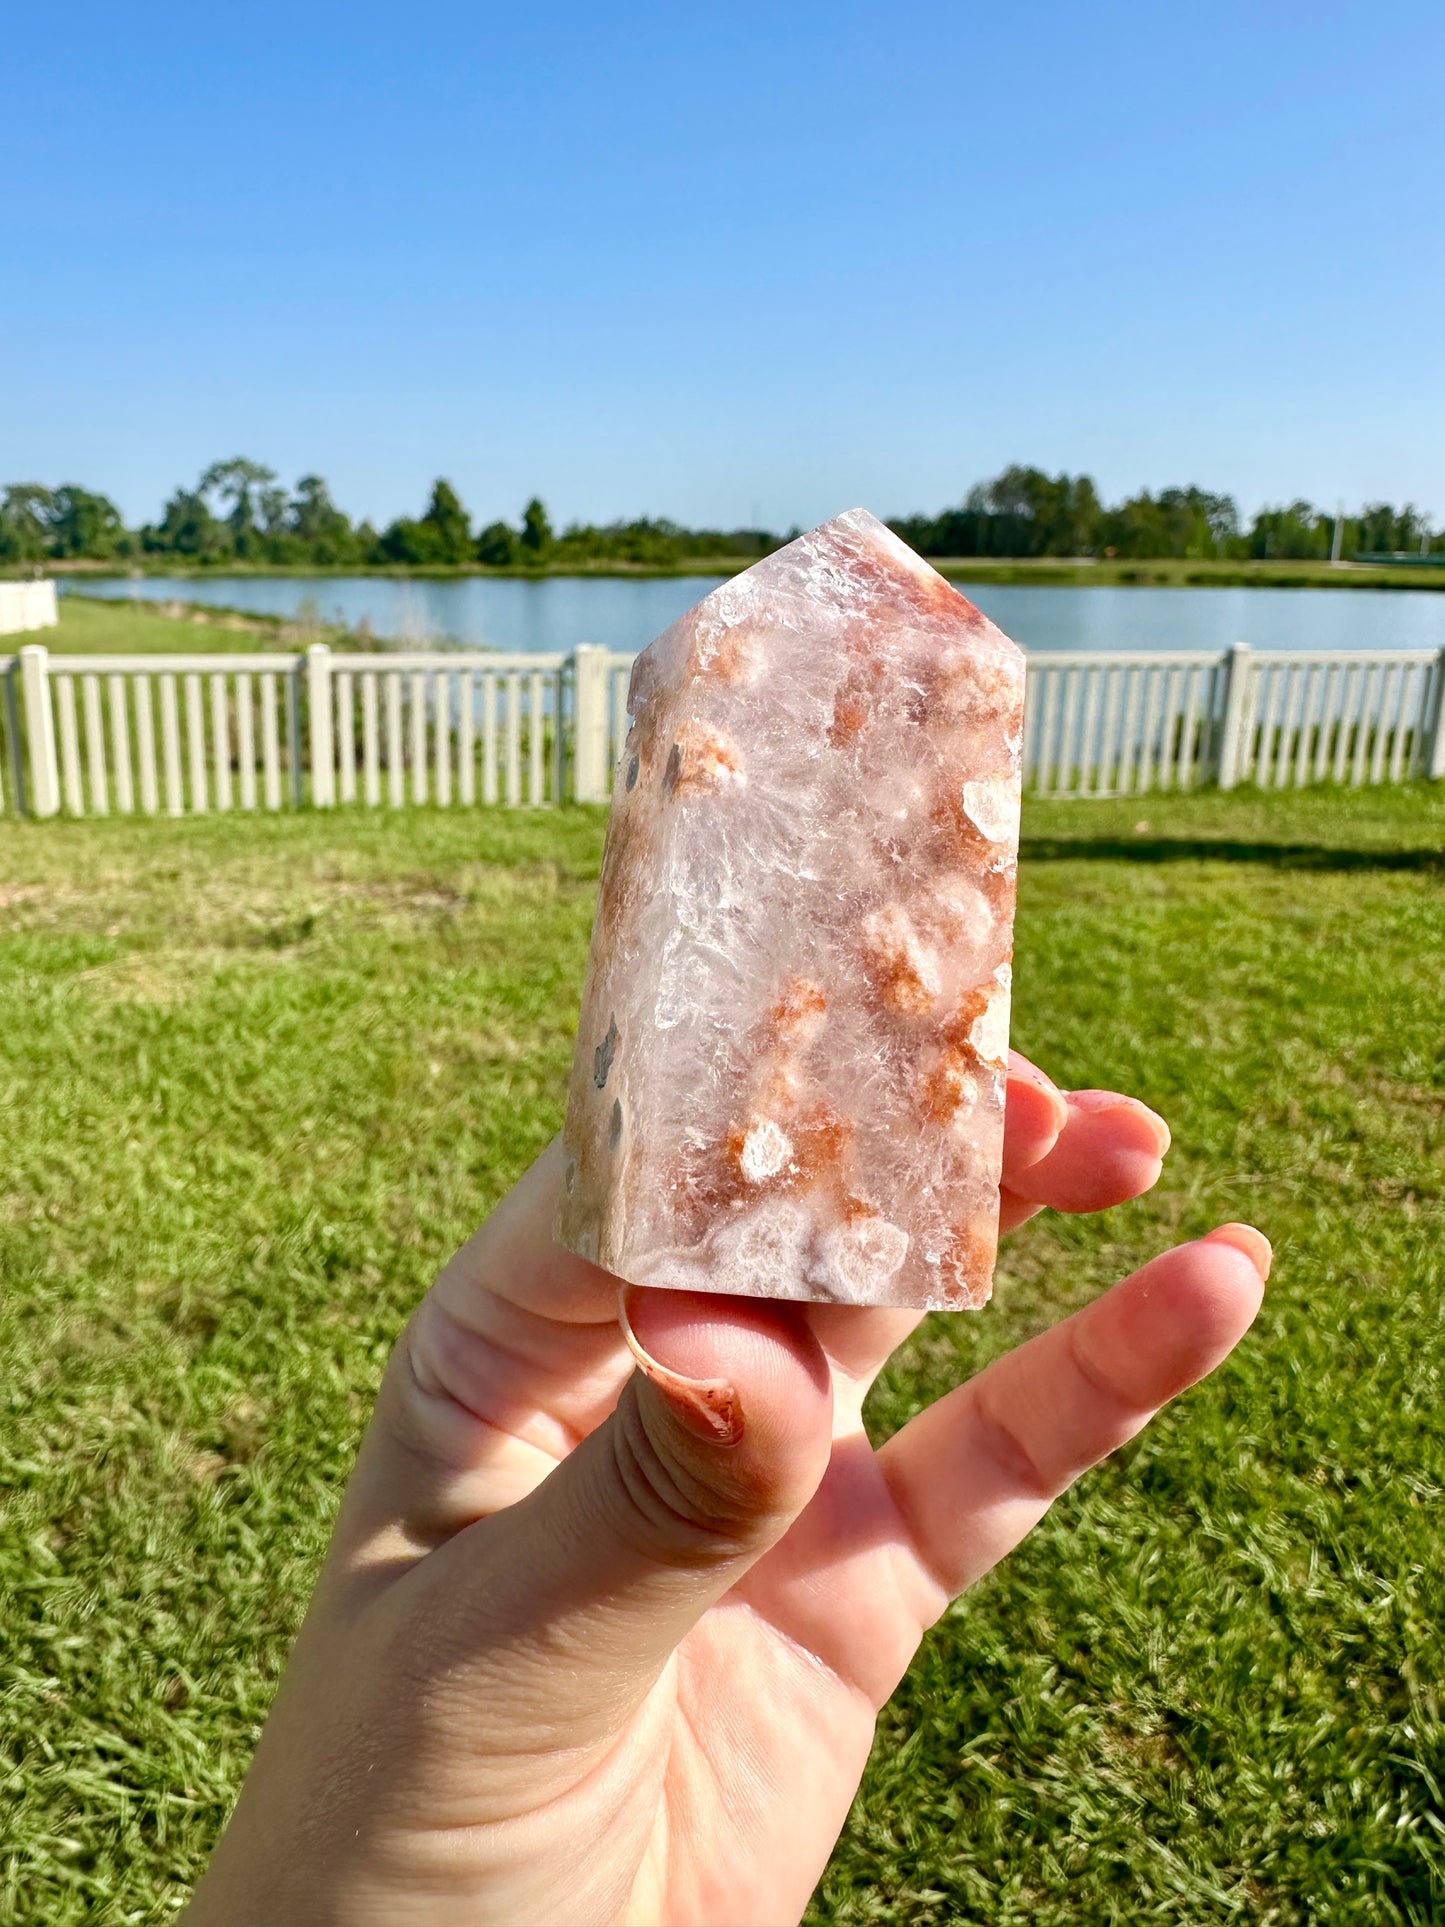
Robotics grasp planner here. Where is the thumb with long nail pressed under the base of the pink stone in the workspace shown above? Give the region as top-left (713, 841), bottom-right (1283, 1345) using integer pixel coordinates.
top-left (424, 1291), bottom-right (832, 1746)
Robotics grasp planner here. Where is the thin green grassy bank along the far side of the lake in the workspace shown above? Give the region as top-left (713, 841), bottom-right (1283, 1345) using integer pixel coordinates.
top-left (25, 555), bottom-right (1445, 592)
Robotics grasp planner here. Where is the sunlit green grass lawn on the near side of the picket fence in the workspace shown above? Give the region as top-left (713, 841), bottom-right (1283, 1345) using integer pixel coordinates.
top-left (0, 788), bottom-right (1445, 1927)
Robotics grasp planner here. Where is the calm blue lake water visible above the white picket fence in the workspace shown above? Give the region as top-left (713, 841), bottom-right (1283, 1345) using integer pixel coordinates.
top-left (60, 576), bottom-right (1445, 651)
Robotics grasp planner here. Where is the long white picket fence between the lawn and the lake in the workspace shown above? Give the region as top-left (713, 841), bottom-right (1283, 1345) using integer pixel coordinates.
top-left (0, 644), bottom-right (1445, 817)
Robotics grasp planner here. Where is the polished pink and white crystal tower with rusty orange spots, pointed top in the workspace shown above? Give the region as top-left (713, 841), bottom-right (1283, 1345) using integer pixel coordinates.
top-left (559, 509), bottom-right (1023, 1307)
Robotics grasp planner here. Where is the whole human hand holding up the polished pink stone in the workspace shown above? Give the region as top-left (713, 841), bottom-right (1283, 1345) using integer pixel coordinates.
top-left (189, 1054), bottom-right (1270, 1927)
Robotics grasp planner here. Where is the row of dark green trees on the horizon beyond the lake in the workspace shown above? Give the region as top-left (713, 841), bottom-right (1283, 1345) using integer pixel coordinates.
top-left (0, 457), bottom-right (1445, 568)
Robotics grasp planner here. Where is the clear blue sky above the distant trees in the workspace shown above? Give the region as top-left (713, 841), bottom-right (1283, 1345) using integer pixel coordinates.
top-left (0, 0), bottom-right (1445, 526)
